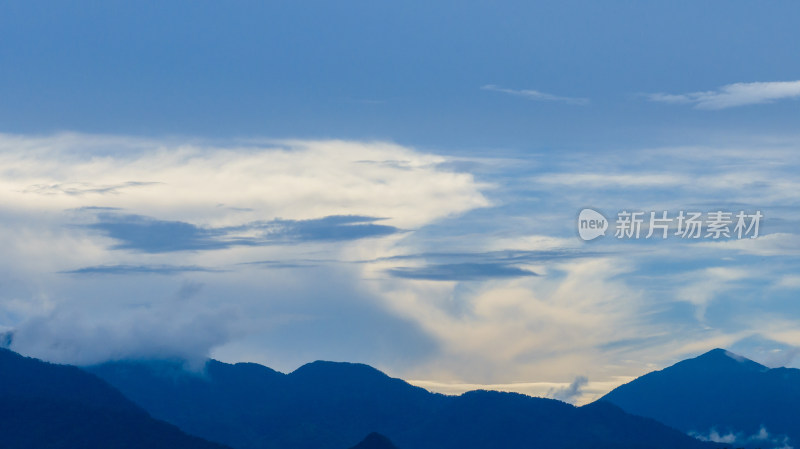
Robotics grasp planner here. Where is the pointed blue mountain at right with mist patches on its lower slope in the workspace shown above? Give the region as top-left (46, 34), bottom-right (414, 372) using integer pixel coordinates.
top-left (602, 349), bottom-right (800, 449)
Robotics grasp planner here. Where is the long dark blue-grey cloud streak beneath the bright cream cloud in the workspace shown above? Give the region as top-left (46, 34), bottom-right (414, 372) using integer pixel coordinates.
top-left (85, 211), bottom-right (400, 253)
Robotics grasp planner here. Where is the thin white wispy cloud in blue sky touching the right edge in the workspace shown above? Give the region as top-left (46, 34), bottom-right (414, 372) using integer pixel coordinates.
top-left (647, 80), bottom-right (800, 110)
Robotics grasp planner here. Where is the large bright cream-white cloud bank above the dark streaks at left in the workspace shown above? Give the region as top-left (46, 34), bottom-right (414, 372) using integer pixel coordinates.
top-left (0, 134), bottom-right (488, 227)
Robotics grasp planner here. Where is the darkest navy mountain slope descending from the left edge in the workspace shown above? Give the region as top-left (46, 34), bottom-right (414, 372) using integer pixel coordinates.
top-left (0, 348), bottom-right (230, 449)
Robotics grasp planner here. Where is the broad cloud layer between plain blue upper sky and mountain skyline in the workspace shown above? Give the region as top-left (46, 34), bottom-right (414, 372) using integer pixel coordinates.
top-left (0, 130), bottom-right (800, 403)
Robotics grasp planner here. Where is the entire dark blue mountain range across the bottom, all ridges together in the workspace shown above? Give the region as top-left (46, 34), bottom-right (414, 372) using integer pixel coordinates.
top-left (0, 349), bottom-right (800, 449)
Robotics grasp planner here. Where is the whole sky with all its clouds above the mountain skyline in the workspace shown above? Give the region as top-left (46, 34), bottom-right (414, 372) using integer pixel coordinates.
top-left (0, 0), bottom-right (800, 403)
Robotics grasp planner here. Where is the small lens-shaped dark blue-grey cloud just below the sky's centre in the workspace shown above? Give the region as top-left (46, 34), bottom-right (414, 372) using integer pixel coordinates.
top-left (387, 263), bottom-right (538, 281)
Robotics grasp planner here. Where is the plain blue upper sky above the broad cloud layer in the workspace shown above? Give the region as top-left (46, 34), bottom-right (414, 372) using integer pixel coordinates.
top-left (6, 1), bottom-right (800, 152)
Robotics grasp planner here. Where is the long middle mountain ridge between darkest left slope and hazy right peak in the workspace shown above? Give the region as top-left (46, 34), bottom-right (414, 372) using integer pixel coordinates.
top-left (88, 361), bottom-right (720, 449)
